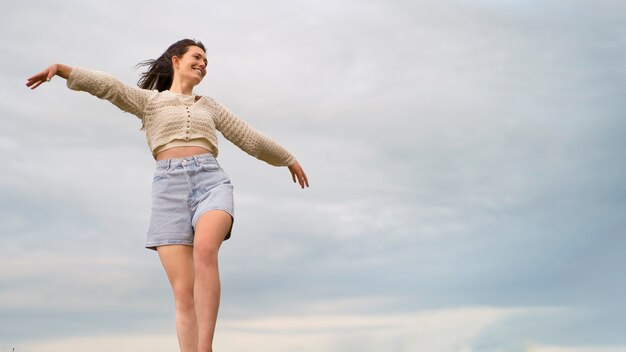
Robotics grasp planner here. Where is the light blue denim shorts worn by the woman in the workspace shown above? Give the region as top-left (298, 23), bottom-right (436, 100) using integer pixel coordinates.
top-left (145, 154), bottom-right (235, 250)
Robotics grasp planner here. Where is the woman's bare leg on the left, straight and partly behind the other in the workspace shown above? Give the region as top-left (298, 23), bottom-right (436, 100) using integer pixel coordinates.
top-left (157, 245), bottom-right (198, 352)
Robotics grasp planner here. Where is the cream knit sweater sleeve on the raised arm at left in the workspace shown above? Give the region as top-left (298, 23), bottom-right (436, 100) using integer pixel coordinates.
top-left (67, 67), bottom-right (157, 119)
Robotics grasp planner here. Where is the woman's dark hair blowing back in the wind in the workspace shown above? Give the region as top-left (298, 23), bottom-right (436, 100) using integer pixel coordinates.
top-left (135, 39), bottom-right (206, 92)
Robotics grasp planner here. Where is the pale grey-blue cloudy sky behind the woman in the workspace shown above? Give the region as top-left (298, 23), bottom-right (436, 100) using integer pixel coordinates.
top-left (0, 0), bottom-right (626, 352)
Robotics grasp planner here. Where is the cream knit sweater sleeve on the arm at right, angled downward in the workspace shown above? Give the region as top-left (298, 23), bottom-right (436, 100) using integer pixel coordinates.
top-left (212, 100), bottom-right (296, 166)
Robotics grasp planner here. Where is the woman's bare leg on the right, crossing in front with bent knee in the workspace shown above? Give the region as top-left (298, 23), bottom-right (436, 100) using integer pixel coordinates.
top-left (193, 210), bottom-right (232, 352)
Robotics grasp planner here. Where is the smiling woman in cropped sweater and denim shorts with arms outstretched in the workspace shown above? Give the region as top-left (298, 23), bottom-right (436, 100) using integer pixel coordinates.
top-left (26, 39), bottom-right (309, 352)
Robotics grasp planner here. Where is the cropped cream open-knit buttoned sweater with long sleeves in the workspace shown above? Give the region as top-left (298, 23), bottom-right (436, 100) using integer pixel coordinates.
top-left (67, 67), bottom-right (295, 166)
